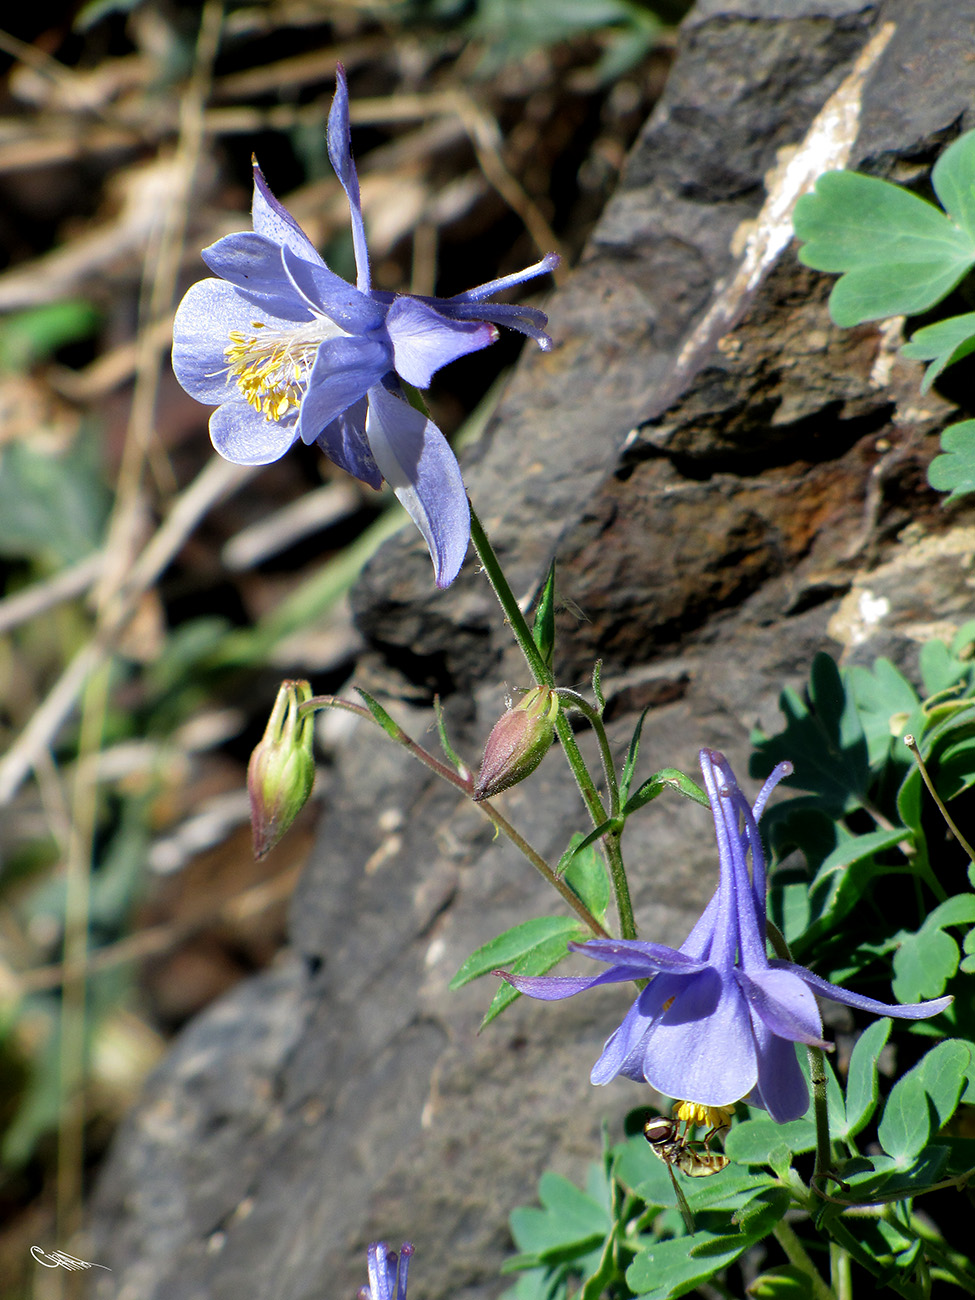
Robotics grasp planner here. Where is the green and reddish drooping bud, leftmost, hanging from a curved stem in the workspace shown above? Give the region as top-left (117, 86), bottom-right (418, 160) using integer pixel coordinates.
top-left (247, 681), bottom-right (315, 858)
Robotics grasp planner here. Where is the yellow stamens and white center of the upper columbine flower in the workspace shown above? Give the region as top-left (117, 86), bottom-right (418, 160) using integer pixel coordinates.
top-left (224, 317), bottom-right (346, 423)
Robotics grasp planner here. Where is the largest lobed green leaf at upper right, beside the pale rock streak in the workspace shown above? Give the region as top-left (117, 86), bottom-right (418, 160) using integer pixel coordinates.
top-left (794, 172), bottom-right (975, 326)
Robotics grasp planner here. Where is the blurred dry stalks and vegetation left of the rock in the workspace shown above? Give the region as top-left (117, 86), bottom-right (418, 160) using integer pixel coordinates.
top-left (0, 0), bottom-right (688, 1300)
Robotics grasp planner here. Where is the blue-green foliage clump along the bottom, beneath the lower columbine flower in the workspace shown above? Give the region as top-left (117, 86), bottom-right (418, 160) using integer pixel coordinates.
top-left (504, 1019), bottom-right (975, 1300)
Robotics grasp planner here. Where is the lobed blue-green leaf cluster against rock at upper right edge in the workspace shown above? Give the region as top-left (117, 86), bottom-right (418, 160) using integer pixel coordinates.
top-left (794, 131), bottom-right (975, 501)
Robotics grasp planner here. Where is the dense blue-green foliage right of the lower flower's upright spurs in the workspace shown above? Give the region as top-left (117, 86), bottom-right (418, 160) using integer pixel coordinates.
top-left (753, 642), bottom-right (975, 1001)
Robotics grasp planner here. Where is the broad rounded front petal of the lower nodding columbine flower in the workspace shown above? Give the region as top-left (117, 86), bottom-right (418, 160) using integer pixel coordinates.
top-left (644, 969), bottom-right (758, 1106)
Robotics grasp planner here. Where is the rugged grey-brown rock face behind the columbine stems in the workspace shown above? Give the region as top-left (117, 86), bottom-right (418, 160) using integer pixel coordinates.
top-left (88, 0), bottom-right (975, 1300)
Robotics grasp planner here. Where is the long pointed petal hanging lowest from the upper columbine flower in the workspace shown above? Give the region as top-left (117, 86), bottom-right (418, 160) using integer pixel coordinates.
top-left (365, 384), bottom-right (471, 588)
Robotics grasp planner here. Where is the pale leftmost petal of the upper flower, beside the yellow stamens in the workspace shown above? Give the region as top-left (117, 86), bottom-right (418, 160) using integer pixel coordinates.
top-left (173, 280), bottom-right (305, 406)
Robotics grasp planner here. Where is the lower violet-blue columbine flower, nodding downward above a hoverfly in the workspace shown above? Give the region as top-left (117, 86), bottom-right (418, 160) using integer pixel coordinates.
top-left (498, 749), bottom-right (952, 1123)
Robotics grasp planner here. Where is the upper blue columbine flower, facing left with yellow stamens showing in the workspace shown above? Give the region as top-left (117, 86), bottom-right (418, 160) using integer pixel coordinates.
top-left (173, 66), bottom-right (559, 586)
